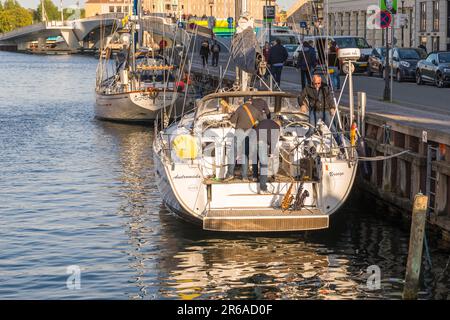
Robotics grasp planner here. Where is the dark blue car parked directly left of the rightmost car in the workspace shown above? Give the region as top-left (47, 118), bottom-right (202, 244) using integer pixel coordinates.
top-left (389, 48), bottom-right (427, 82)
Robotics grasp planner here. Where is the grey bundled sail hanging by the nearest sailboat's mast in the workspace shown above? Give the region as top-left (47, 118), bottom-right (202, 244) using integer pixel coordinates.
top-left (231, 16), bottom-right (261, 74)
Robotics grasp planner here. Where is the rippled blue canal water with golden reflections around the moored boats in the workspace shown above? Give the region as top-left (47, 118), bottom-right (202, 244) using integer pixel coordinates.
top-left (0, 52), bottom-right (450, 299)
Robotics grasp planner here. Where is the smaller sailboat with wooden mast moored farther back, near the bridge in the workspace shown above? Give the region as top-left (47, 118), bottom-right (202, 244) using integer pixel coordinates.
top-left (95, 1), bottom-right (182, 122)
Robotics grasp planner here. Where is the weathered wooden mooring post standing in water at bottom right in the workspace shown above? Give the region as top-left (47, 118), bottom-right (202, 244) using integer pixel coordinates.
top-left (403, 193), bottom-right (428, 300)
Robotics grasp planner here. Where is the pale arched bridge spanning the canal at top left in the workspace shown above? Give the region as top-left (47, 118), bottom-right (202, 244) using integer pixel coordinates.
top-left (0, 14), bottom-right (123, 52)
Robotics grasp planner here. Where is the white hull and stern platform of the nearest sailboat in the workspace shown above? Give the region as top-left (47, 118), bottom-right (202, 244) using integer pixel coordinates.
top-left (153, 139), bottom-right (356, 232)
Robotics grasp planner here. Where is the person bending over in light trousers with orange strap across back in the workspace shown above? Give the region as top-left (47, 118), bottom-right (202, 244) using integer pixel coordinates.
top-left (225, 102), bottom-right (264, 181)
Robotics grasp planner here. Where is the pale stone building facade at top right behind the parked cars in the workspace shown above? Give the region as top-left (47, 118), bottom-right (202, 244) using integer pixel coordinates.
top-left (324, 0), bottom-right (450, 51)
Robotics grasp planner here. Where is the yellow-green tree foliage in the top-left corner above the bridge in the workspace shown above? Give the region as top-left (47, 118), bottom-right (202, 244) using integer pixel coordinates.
top-left (0, 0), bottom-right (33, 33)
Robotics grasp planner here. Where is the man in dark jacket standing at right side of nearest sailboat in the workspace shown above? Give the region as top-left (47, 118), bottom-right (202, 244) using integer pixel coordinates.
top-left (299, 75), bottom-right (341, 145)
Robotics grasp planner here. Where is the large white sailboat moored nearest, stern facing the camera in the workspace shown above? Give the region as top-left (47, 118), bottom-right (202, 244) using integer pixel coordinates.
top-left (153, 3), bottom-right (357, 232)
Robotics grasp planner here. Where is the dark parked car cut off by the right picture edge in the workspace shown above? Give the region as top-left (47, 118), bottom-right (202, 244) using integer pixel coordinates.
top-left (416, 51), bottom-right (450, 88)
